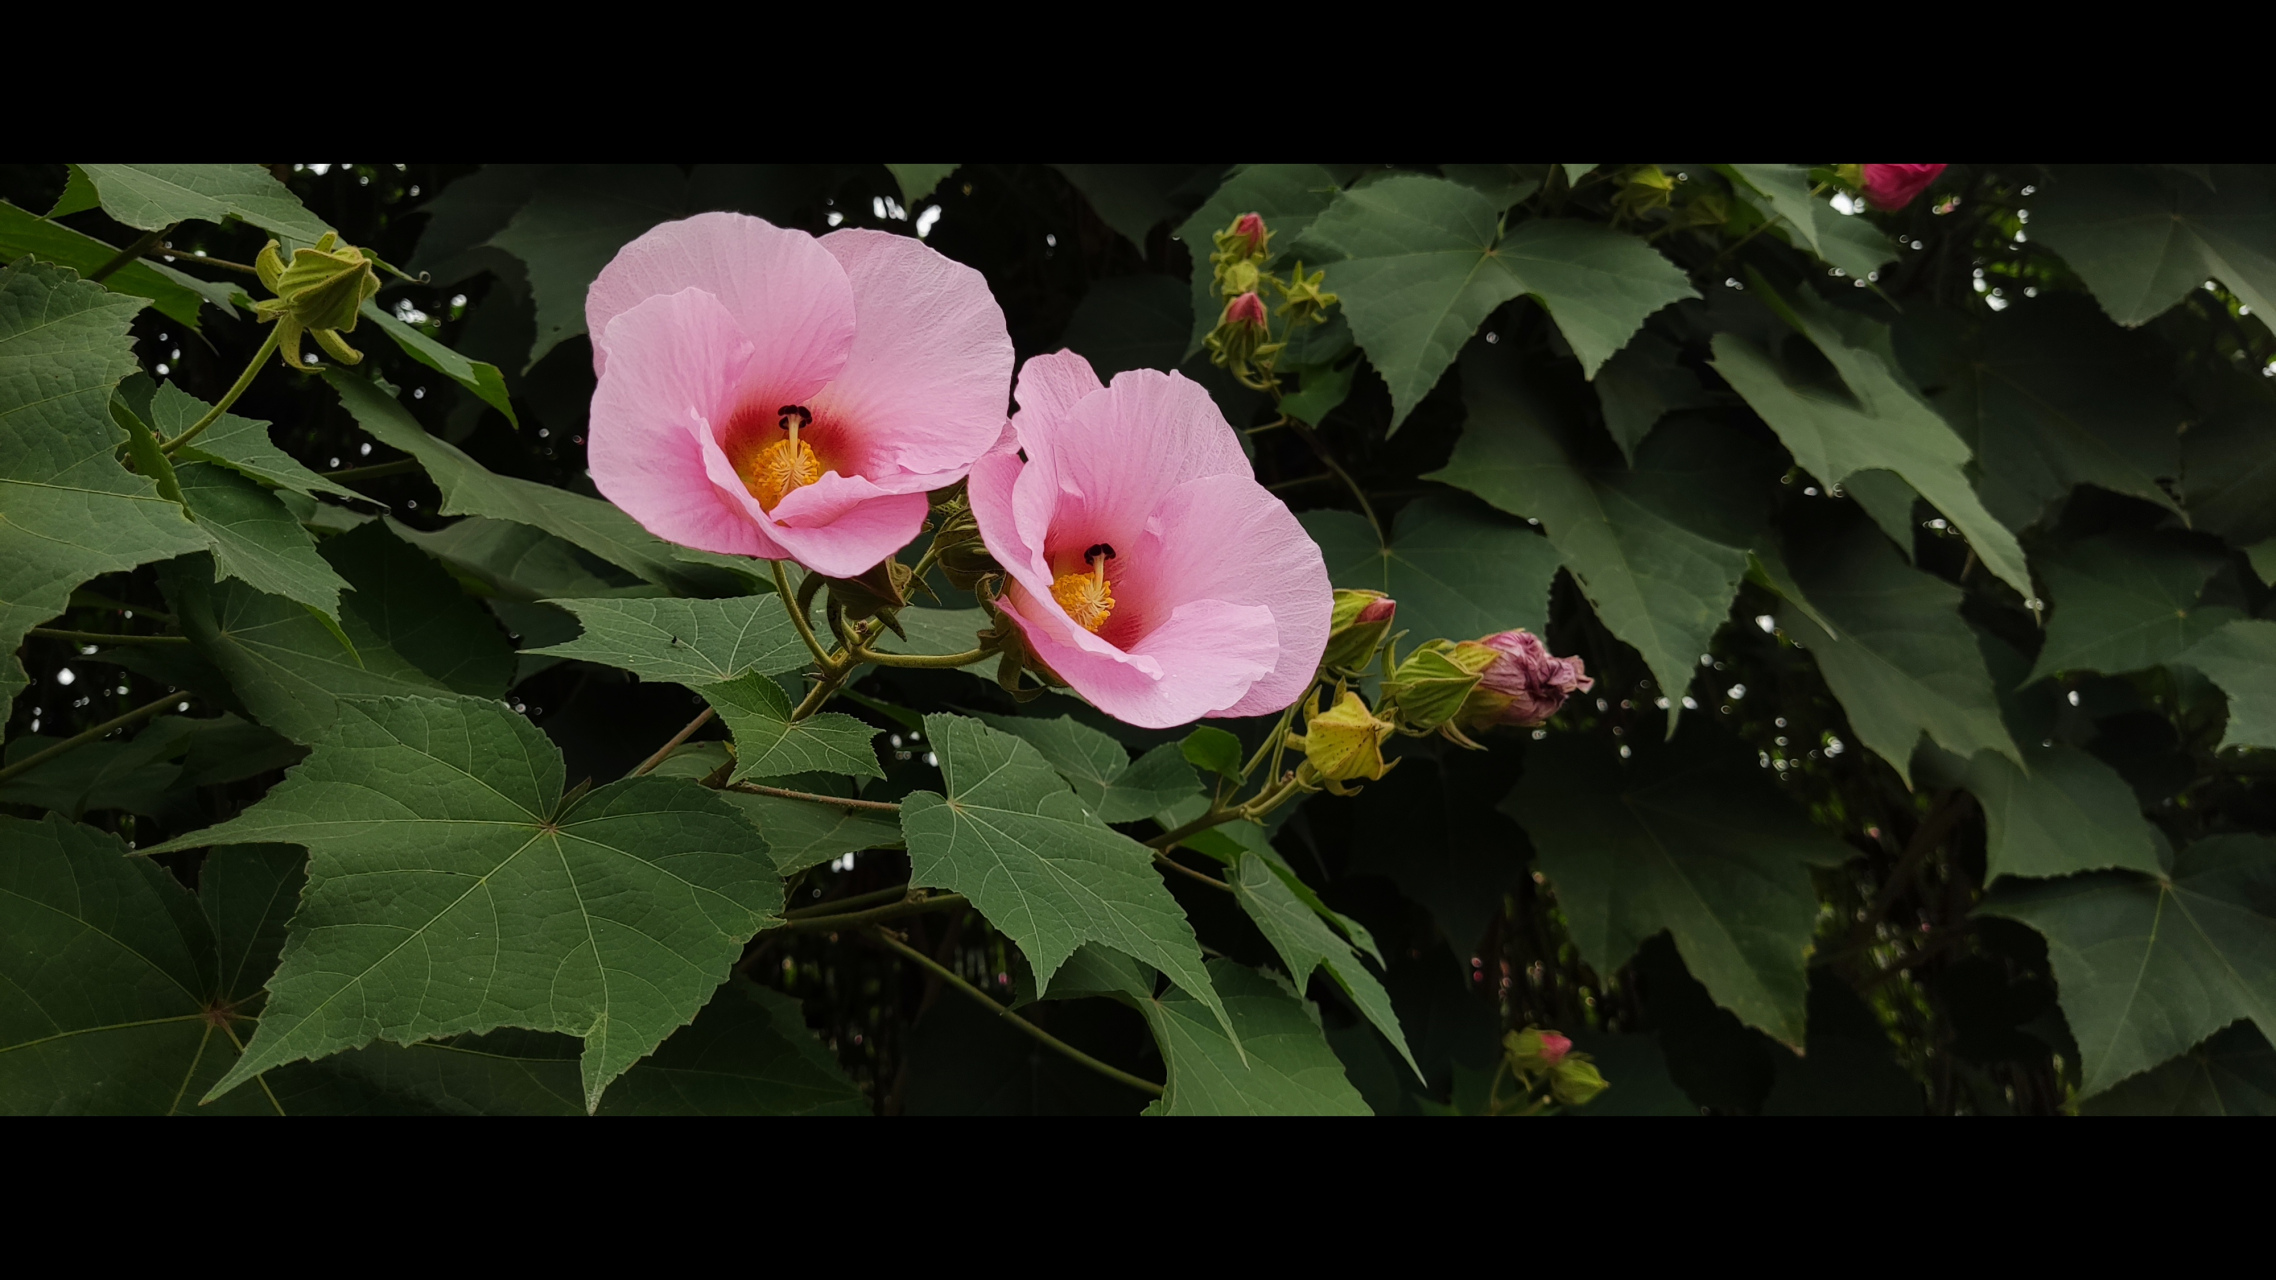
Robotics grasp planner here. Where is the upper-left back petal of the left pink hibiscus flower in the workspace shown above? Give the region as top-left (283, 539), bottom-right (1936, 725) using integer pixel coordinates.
top-left (585, 214), bottom-right (855, 387)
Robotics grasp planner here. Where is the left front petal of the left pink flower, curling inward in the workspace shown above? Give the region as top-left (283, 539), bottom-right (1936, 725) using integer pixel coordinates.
top-left (585, 289), bottom-right (787, 556)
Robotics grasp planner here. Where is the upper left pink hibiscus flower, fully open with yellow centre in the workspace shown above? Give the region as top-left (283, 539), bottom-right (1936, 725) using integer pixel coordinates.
top-left (585, 214), bottom-right (1013, 579)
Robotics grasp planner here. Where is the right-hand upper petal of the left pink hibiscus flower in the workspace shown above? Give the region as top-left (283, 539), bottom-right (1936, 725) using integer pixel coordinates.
top-left (810, 228), bottom-right (1013, 483)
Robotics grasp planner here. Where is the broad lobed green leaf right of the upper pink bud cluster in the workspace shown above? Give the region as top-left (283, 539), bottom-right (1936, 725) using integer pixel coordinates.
top-left (1304, 175), bottom-right (1698, 430)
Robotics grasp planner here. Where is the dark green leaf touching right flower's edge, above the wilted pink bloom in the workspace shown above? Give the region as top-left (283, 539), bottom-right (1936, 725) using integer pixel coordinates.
top-left (1297, 494), bottom-right (1559, 649)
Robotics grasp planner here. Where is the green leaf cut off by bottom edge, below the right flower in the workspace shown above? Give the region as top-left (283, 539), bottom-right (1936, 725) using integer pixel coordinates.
top-left (1138, 961), bottom-right (1370, 1116)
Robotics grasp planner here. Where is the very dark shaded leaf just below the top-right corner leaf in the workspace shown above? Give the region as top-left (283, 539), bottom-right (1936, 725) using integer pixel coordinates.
top-left (1898, 294), bottom-right (2196, 528)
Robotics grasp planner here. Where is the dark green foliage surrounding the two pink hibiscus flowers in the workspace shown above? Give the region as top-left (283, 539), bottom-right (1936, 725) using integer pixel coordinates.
top-left (13, 164), bottom-right (2276, 1116)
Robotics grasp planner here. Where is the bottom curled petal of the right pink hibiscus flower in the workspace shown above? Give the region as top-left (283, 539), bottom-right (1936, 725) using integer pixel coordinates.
top-left (1006, 592), bottom-right (1279, 729)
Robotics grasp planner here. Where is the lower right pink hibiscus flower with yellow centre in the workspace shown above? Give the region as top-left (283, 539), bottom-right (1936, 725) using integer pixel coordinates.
top-left (970, 351), bottom-right (1334, 729)
